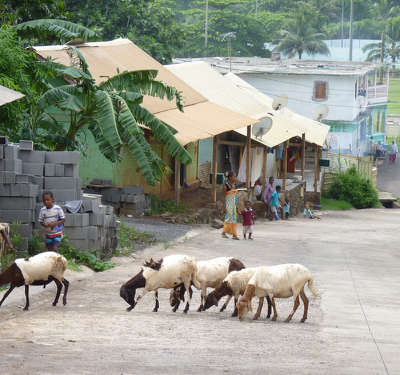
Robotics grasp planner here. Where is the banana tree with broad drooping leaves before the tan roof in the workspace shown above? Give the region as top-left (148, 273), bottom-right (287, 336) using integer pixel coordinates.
top-left (37, 46), bottom-right (192, 185)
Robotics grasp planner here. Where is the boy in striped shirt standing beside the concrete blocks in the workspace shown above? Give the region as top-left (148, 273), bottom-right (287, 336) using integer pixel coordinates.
top-left (39, 191), bottom-right (65, 253)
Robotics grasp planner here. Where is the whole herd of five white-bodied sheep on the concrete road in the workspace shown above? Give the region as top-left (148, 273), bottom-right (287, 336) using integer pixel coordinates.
top-left (0, 251), bottom-right (317, 323)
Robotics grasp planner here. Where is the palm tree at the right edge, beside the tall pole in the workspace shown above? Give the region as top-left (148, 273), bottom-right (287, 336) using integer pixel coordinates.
top-left (363, 19), bottom-right (400, 77)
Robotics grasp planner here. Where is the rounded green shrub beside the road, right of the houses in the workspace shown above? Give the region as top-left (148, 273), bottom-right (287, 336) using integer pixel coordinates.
top-left (329, 165), bottom-right (379, 208)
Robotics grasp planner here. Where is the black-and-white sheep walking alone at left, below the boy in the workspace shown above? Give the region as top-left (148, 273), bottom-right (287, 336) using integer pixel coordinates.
top-left (0, 251), bottom-right (69, 311)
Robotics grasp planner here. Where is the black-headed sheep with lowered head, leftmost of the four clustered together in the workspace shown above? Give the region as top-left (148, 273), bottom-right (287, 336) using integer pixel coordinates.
top-left (120, 254), bottom-right (200, 313)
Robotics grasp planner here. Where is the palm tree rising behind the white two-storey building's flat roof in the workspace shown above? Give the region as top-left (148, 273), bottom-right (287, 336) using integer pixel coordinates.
top-left (274, 14), bottom-right (331, 59)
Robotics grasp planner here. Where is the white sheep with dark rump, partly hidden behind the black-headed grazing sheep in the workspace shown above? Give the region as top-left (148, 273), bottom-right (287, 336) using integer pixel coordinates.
top-left (169, 257), bottom-right (245, 312)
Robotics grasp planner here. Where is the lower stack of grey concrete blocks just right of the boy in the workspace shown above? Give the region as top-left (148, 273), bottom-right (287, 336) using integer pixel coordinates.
top-left (64, 194), bottom-right (120, 257)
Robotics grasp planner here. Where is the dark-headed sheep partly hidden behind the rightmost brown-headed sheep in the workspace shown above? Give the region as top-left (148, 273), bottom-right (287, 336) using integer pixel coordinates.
top-left (204, 267), bottom-right (271, 318)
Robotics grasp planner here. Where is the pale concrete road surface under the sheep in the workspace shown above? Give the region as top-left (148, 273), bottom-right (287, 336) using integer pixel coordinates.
top-left (0, 209), bottom-right (400, 375)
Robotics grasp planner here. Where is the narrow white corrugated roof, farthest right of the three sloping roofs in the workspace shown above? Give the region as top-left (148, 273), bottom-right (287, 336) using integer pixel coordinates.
top-left (225, 73), bottom-right (330, 146)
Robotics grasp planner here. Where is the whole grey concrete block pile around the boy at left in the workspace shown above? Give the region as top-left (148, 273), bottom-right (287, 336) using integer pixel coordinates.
top-left (0, 137), bottom-right (119, 255)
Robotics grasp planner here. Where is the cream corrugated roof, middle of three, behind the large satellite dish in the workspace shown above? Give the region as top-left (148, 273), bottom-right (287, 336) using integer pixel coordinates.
top-left (166, 62), bottom-right (309, 147)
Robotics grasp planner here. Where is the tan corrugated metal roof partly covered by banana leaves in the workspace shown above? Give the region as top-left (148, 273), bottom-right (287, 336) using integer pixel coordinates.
top-left (35, 39), bottom-right (258, 145)
